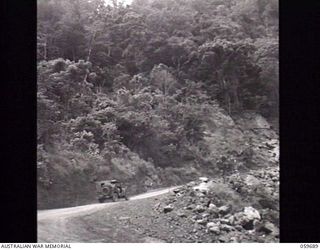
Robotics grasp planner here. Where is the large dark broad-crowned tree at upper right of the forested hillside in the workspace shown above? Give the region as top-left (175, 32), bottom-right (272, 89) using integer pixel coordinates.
top-left (198, 39), bottom-right (264, 113)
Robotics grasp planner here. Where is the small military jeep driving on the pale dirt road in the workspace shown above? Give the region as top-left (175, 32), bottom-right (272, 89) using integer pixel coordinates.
top-left (96, 180), bottom-right (128, 203)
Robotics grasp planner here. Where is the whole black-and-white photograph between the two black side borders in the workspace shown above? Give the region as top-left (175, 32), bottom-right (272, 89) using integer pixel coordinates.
top-left (36, 0), bottom-right (281, 243)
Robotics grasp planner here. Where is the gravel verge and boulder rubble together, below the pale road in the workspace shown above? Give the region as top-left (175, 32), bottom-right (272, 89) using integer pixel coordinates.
top-left (56, 166), bottom-right (279, 243)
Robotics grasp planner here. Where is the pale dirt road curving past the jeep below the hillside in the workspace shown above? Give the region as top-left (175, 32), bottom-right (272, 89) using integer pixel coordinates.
top-left (38, 186), bottom-right (177, 242)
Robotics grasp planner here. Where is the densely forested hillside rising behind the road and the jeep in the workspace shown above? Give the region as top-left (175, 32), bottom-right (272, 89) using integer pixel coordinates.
top-left (37, 0), bottom-right (279, 207)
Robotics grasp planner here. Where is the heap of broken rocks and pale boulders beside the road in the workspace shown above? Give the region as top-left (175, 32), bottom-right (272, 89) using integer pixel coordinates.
top-left (154, 170), bottom-right (279, 243)
